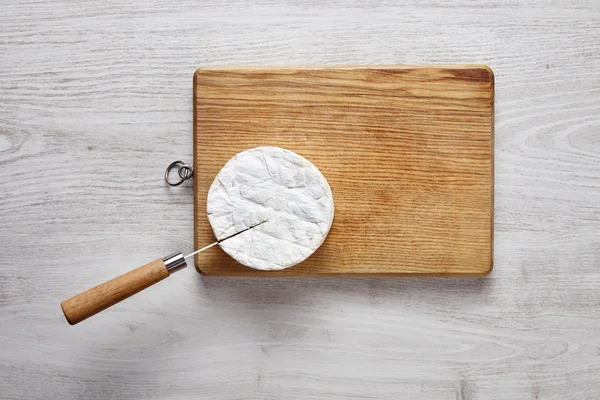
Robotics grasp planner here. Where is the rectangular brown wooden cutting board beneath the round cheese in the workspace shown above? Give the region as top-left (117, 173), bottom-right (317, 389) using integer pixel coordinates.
top-left (194, 65), bottom-right (494, 276)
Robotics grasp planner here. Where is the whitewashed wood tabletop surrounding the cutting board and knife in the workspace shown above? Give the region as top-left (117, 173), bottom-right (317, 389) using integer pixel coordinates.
top-left (0, 0), bottom-right (600, 400)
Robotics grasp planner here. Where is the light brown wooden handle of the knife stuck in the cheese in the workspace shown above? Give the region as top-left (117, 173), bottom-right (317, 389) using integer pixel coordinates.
top-left (60, 258), bottom-right (169, 325)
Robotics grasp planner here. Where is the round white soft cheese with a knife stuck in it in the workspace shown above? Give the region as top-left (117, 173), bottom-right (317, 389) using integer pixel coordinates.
top-left (207, 147), bottom-right (333, 270)
